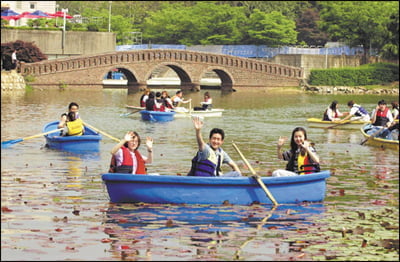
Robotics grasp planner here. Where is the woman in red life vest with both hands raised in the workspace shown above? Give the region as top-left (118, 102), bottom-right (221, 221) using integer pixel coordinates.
top-left (109, 131), bottom-right (153, 175)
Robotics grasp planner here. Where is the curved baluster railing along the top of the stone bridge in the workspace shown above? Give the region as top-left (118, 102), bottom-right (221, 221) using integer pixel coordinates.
top-left (20, 49), bottom-right (303, 78)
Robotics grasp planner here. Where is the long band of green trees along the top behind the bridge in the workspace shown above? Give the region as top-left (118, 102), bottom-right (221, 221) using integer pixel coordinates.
top-left (10, 1), bottom-right (399, 59)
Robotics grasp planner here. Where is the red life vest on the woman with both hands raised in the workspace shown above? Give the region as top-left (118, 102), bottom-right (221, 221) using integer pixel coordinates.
top-left (108, 146), bottom-right (147, 175)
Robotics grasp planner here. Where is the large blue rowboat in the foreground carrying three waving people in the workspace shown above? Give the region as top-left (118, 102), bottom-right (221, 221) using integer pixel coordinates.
top-left (102, 170), bottom-right (330, 205)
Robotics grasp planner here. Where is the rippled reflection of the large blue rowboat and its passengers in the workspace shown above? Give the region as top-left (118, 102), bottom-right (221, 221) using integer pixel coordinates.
top-left (102, 203), bottom-right (325, 260)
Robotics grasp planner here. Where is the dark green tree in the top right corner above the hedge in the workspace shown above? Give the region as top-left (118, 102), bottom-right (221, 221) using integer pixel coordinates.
top-left (319, 1), bottom-right (399, 58)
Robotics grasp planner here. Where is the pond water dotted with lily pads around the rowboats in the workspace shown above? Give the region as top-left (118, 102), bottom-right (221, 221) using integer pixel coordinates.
top-left (1, 89), bottom-right (399, 261)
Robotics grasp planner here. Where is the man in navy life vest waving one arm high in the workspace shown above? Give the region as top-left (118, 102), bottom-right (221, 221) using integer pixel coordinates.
top-left (188, 117), bottom-right (242, 176)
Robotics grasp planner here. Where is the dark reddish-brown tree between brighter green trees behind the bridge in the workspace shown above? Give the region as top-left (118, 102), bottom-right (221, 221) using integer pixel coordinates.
top-left (296, 8), bottom-right (328, 46)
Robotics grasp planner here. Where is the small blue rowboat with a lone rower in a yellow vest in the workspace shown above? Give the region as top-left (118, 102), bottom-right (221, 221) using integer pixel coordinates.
top-left (43, 121), bottom-right (102, 152)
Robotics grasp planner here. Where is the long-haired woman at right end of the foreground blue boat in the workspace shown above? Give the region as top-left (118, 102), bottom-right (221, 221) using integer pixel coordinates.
top-left (272, 127), bottom-right (320, 176)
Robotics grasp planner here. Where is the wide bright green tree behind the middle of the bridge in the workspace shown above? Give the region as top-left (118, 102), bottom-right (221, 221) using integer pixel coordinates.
top-left (143, 2), bottom-right (246, 45)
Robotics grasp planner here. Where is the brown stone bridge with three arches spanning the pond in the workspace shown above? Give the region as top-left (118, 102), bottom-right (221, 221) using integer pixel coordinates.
top-left (19, 49), bottom-right (303, 91)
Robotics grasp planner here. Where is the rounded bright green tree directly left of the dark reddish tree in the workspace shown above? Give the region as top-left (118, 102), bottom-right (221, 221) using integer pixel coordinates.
top-left (247, 9), bottom-right (297, 46)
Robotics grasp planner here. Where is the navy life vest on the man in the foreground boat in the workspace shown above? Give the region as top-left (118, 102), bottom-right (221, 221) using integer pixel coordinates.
top-left (187, 149), bottom-right (223, 176)
